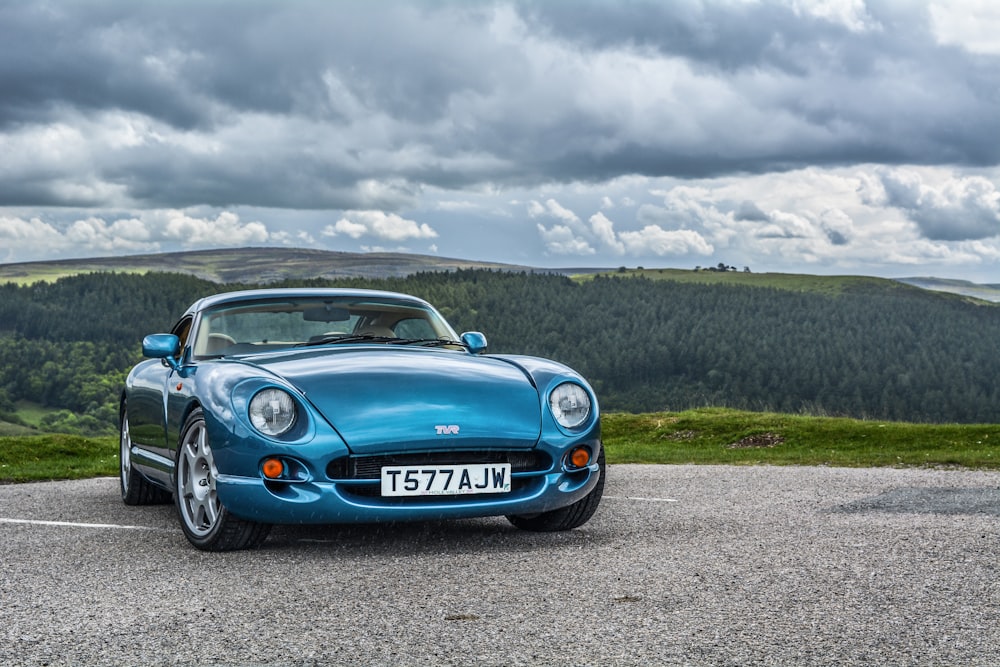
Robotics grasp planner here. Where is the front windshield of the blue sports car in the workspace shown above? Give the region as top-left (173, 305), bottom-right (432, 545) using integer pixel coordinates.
top-left (194, 296), bottom-right (458, 357)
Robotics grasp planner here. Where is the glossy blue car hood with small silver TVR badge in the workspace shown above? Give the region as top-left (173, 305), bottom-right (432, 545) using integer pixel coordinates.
top-left (245, 346), bottom-right (541, 454)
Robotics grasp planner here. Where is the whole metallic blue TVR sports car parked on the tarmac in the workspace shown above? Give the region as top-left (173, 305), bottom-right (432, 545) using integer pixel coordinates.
top-left (120, 289), bottom-right (605, 551)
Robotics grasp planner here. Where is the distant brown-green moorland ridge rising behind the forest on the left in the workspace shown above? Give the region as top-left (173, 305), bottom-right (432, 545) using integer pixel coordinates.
top-left (0, 248), bottom-right (536, 284)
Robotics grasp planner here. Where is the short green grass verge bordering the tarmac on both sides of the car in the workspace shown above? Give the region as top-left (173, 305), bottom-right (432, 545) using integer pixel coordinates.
top-left (0, 408), bottom-right (1000, 483)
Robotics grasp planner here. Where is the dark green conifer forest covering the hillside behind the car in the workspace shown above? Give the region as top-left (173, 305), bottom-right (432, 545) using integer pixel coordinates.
top-left (0, 270), bottom-right (1000, 433)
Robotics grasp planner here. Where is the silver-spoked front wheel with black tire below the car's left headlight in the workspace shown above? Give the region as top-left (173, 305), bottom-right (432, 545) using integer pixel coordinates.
top-left (174, 408), bottom-right (271, 551)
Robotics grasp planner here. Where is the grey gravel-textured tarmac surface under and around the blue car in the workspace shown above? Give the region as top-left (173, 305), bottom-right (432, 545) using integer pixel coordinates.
top-left (0, 465), bottom-right (1000, 666)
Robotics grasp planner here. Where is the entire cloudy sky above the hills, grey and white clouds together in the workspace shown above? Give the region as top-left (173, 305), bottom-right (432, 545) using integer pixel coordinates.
top-left (0, 0), bottom-right (1000, 283)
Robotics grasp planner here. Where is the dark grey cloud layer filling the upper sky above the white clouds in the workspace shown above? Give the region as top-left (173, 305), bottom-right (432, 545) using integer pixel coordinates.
top-left (0, 0), bottom-right (1000, 214)
